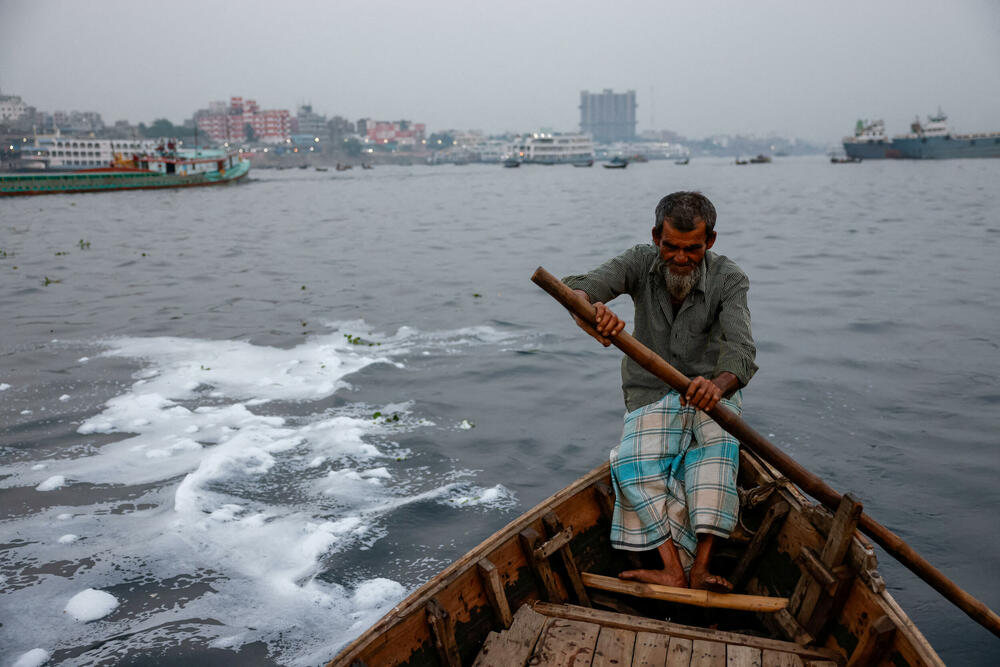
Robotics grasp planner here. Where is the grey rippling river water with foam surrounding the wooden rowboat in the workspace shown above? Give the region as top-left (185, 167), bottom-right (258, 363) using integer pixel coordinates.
top-left (0, 157), bottom-right (1000, 665)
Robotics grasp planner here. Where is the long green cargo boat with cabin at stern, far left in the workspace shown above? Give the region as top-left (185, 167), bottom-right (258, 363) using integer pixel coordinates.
top-left (0, 142), bottom-right (250, 196)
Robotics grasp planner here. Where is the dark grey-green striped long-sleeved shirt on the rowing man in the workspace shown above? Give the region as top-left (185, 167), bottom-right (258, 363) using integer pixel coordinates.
top-left (563, 244), bottom-right (757, 412)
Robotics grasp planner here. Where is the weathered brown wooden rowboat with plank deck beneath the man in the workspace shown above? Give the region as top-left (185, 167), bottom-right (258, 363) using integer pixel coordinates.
top-left (329, 448), bottom-right (943, 667)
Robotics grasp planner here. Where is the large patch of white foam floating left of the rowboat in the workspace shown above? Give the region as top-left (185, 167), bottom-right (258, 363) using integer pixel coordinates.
top-left (0, 321), bottom-right (516, 664)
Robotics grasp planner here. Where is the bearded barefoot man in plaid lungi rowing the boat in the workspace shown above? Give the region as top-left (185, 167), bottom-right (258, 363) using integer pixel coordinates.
top-left (564, 192), bottom-right (757, 590)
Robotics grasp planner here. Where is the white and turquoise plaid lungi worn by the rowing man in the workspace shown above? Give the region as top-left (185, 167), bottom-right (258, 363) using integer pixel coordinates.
top-left (611, 391), bottom-right (743, 569)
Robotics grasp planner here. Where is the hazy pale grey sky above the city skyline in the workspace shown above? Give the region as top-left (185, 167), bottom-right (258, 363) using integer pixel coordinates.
top-left (0, 0), bottom-right (1000, 143)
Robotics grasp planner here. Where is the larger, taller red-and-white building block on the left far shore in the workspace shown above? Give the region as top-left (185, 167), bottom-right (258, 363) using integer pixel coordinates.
top-left (194, 97), bottom-right (292, 144)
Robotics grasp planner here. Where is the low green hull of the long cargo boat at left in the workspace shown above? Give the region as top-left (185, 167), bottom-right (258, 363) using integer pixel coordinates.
top-left (0, 160), bottom-right (250, 196)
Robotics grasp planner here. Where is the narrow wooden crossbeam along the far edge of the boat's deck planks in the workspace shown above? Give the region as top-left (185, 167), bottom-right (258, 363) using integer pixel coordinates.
top-left (533, 602), bottom-right (840, 660)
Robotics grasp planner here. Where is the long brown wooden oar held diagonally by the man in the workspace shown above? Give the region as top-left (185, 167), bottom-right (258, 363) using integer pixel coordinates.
top-left (531, 267), bottom-right (1000, 637)
